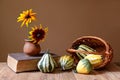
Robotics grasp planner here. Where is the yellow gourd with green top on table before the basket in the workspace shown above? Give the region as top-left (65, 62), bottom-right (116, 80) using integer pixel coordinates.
top-left (76, 59), bottom-right (92, 74)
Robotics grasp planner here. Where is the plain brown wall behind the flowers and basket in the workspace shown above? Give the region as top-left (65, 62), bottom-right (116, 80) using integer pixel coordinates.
top-left (0, 0), bottom-right (120, 61)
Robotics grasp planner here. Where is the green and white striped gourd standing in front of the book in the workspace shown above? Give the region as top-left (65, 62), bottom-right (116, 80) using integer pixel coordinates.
top-left (37, 51), bottom-right (57, 73)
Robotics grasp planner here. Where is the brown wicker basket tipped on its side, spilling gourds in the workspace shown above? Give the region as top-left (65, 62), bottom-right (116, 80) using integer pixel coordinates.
top-left (67, 36), bottom-right (113, 69)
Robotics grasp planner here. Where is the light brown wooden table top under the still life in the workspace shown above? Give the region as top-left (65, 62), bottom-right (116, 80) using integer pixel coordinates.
top-left (0, 63), bottom-right (120, 80)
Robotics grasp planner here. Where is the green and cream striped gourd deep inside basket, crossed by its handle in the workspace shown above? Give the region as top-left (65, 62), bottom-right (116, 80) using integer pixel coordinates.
top-left (76, 44), bottom-right (96, 59)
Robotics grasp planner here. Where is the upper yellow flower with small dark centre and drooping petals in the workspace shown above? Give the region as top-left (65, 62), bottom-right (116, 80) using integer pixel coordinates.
top-left (17, 9), bottom-right (36, 27)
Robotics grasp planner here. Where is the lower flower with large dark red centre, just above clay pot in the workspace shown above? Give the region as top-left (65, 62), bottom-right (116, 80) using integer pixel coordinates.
top-left (29, 24), bottom-right (48, 44)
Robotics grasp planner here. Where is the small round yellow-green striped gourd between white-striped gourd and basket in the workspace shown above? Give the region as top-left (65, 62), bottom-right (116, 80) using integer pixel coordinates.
top-left (59, 55), bottom-right (74, 70)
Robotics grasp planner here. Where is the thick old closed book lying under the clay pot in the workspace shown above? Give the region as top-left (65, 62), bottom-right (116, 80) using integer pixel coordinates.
top-left (7, 53), bottom-right (59, 72)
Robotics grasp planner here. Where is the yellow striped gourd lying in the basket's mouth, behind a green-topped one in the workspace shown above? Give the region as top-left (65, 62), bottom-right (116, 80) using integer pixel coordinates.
top-left (85, 54), bottom-right (103, 68)
